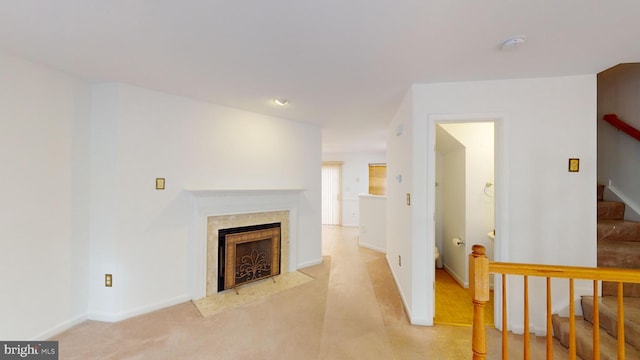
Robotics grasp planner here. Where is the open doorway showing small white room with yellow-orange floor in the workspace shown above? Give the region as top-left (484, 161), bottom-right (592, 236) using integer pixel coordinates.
top-left (434, 119), bottom-right (496, 325)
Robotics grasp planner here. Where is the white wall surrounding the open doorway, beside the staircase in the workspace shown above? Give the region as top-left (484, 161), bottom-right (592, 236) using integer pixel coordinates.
top-left (387, 75), bottom-right (596, 330)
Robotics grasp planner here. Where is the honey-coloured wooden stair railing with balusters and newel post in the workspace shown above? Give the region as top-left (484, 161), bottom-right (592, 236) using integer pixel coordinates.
top-left (469, 245), bottom-right (640, 360)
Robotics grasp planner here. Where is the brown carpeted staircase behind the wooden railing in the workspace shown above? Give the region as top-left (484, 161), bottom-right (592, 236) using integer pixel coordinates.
top-left (553, 185), bottom-right (640, 360)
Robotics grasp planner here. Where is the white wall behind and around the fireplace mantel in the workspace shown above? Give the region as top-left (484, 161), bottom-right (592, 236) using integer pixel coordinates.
top-left (89, 84), bottom-right (322, 321)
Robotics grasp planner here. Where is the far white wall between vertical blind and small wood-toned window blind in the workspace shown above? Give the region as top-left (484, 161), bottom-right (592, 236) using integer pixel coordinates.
top-left (322, 152), bottom-right (387, 226)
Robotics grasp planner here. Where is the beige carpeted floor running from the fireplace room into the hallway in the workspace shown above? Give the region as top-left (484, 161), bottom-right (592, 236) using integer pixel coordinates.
top-left (52, 227), bottom-right (567, 360)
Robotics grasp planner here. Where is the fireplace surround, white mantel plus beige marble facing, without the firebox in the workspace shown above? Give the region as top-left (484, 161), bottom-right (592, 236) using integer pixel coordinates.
top-left (189, 189), bottom-right (304, 300)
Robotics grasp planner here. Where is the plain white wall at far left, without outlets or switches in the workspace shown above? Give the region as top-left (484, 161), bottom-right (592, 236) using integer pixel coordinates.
top-left (0, 55), bottom-right (90, 340)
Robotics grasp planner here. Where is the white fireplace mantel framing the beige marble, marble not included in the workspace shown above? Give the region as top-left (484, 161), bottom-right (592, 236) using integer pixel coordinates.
top-left (186, 189), bottom-right (305, 299)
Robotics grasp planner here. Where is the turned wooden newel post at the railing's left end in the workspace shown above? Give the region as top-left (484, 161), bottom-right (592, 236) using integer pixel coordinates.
top-left (469, 245), bottom-right (489, 360)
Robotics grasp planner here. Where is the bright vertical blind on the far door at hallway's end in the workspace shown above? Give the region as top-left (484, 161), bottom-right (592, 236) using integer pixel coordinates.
top-left (322, 163), bottom-right (342, 225)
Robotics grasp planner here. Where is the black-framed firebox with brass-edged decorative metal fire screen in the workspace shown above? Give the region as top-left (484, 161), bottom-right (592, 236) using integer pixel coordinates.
top-left (218, 223), bottom-right (280, 291)
